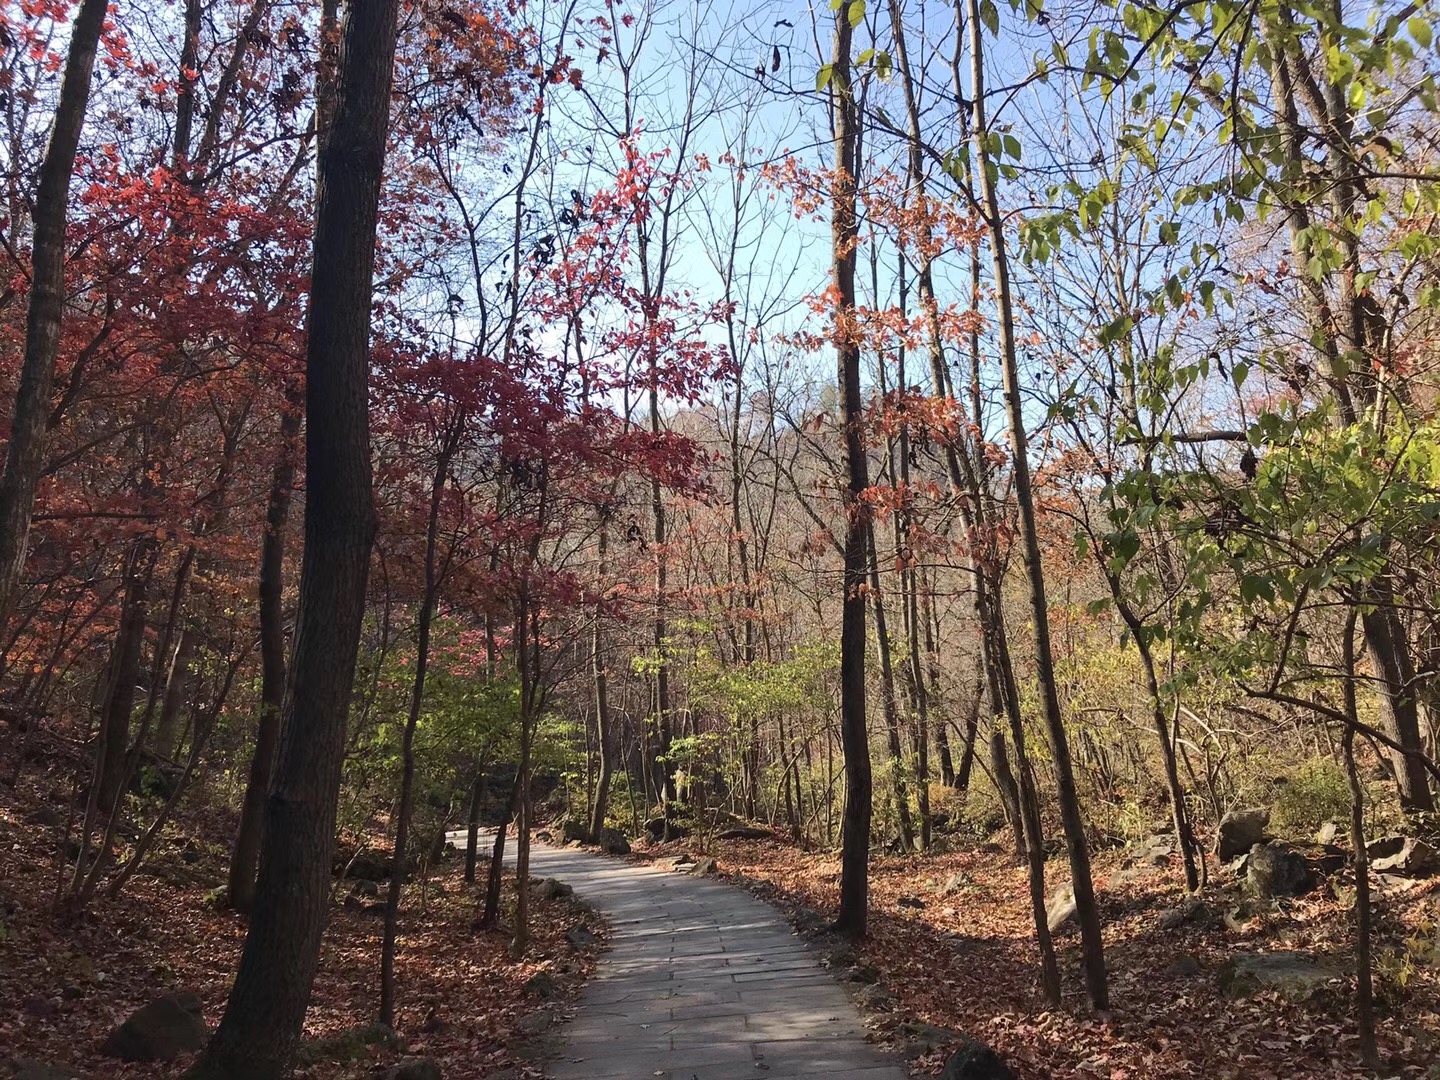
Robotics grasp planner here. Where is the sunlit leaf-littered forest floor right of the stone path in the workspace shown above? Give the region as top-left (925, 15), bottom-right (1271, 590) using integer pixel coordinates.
top-left (636, 840), bottom-right (1440, 1080)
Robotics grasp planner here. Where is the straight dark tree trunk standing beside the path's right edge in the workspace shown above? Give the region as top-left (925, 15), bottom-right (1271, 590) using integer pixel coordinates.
top-left (829, 0), bottom-right (871, 937)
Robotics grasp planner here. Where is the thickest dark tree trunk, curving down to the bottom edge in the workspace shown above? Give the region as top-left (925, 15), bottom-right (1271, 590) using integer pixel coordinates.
top-left (192, 0), bottom-right (399, 1080)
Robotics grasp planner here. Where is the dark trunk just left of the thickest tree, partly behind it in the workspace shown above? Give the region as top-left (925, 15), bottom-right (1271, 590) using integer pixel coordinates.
top-left (229, 402), bottom-right (300, 912)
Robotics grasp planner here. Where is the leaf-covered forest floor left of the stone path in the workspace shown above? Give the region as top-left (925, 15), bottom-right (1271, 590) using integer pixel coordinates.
top-left (0, 778), bottom-right (603, 1080)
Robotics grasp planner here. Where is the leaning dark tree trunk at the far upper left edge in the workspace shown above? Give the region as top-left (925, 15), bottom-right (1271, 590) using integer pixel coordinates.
top-left (0, 0), bottom-right (108, 626)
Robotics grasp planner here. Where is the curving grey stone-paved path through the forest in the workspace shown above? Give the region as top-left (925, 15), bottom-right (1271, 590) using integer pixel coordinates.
top-left (512, 844), bottom-right (906, 1080)
